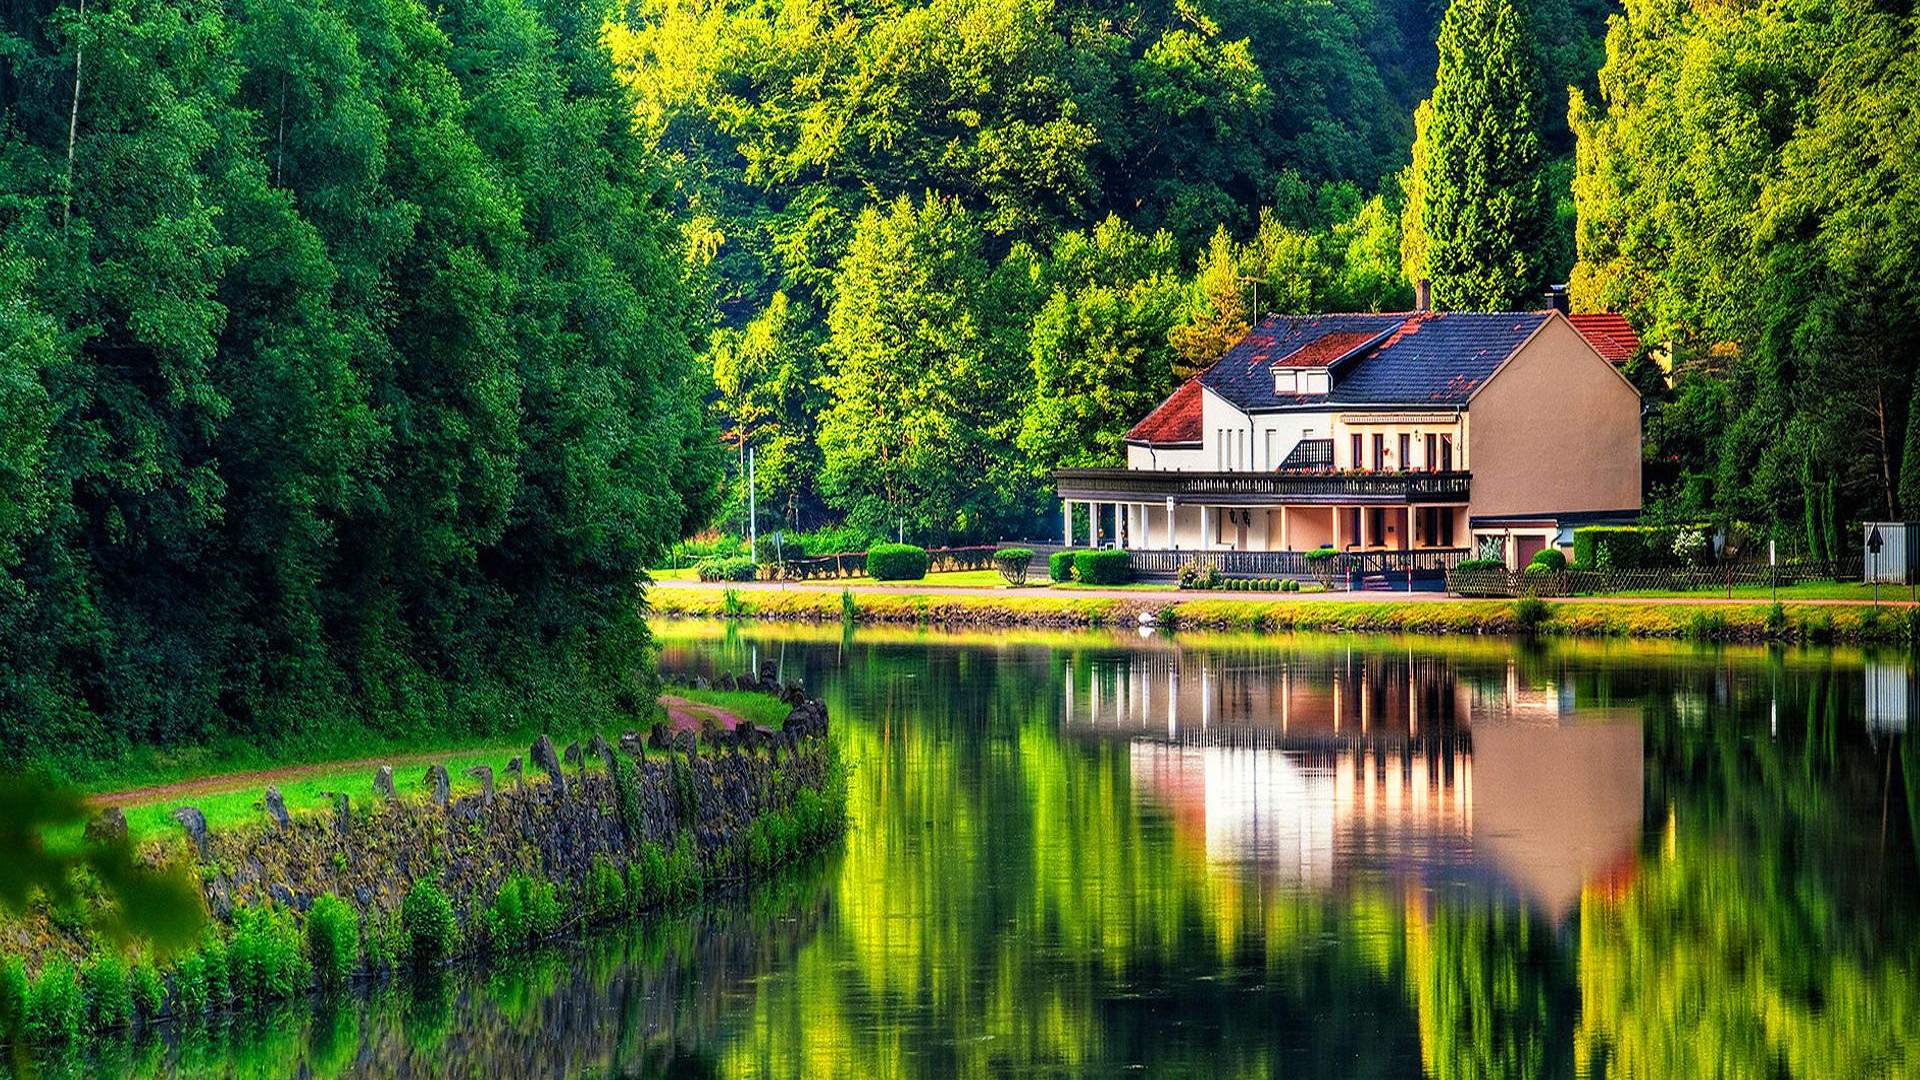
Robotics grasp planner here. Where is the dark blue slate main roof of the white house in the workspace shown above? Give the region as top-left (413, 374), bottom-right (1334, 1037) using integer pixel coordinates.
top-left (1200, 311), bottom-right (1551, 411)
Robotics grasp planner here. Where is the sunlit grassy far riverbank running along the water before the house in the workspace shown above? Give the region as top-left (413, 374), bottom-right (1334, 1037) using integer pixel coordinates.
top-left (649, 582), bottom-right (1920, 644)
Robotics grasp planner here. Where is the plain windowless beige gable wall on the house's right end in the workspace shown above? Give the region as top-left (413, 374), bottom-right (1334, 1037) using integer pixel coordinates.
top-left (1467, 315), bottom-right (1640, 517)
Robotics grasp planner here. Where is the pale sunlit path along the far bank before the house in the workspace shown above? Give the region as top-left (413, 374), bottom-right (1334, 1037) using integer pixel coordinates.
top-left (653, 580), bottom-right (1914, 607)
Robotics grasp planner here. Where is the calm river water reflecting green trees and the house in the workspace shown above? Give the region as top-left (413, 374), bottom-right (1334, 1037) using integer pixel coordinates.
top-left (45, 625), bottom-right (1920, 1078)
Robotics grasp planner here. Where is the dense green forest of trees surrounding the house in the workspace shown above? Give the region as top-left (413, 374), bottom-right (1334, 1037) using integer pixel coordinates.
top-left (0, 0), bottom-right (1920, 757)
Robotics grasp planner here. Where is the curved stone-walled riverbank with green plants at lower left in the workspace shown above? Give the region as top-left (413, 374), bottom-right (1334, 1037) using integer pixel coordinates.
top-left (0, 673), bottom-right (845, 1043)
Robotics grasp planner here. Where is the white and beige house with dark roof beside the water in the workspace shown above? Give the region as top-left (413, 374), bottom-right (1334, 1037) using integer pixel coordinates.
top-left (1054, 299), bottom-right (1640, 568)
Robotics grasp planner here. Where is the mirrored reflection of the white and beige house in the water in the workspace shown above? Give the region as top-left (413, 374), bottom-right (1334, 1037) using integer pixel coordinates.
top-left (1064, 648), bottom-right (1644, 919)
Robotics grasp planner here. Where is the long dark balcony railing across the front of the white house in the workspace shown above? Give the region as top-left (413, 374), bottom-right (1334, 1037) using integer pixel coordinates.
top-left (1054, 469), bottom-right (1473, 505)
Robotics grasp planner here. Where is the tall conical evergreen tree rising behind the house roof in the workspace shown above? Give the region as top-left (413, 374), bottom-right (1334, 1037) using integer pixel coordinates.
top-left (1413, 0), bottom-right (1553, 311)
